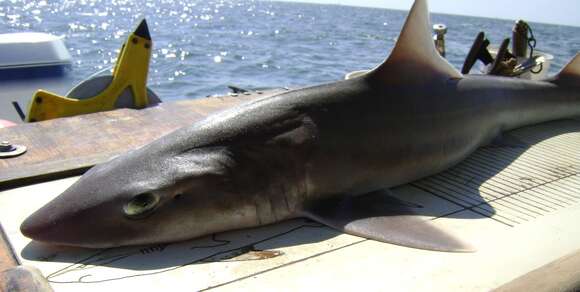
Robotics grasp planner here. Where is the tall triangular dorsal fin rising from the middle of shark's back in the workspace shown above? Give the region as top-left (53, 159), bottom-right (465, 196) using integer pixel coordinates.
top-left (370, 0), bottom-right (463, 84)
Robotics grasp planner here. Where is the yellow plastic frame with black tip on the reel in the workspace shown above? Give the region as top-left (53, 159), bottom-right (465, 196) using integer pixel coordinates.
top-left (26, 20), bottom-right (153, 122)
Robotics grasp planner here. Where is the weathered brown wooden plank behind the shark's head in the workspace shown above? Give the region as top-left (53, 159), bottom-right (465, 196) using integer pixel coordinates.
top-left (0, 89), bottom-right (283, 189)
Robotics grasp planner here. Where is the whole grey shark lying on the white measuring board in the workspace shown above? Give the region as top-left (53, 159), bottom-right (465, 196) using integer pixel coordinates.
top-left (21, 0), bottom-right (580, 251)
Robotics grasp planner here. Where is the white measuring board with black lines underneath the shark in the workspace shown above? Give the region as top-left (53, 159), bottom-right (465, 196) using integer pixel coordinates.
top-left (0, 120), bottom-right (580, 291)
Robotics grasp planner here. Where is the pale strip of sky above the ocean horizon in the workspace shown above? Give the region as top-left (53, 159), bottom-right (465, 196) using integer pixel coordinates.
top-left (283, 0), bottom-right (580, 26)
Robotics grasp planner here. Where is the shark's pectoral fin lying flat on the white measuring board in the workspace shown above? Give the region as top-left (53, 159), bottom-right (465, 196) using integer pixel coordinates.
top-left (307, 191), bottom-right (475, 252)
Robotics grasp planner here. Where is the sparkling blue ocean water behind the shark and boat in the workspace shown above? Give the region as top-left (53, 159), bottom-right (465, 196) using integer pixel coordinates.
top-left (0, 0), bottom-right (580, 100)
